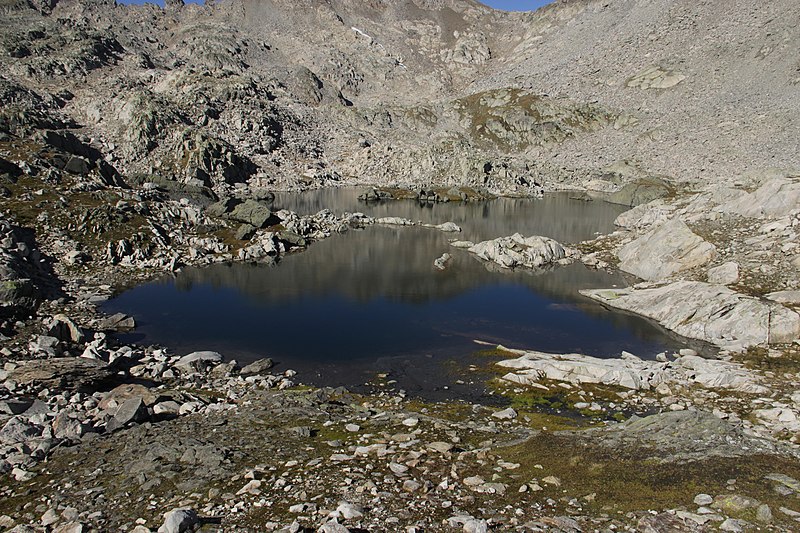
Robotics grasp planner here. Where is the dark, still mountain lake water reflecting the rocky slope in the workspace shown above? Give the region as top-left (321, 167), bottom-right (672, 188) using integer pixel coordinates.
top-left (105, 189), bottom-right (682, 393)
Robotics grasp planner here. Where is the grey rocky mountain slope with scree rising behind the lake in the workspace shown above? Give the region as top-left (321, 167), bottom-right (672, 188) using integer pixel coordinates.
top-left (2, 0), bottom-right (800, 198)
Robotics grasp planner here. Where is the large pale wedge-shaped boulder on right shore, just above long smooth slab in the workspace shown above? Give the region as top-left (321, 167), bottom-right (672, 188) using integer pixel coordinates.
top-left (617, 218), bottom-right (716, 281)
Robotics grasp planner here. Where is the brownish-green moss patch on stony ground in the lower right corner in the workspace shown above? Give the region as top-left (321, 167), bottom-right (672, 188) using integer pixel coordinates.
top-left (499, 433), bottom-right (800, 516)
